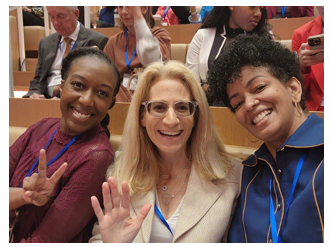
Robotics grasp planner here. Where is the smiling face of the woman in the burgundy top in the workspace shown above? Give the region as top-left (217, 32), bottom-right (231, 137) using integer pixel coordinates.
top-left (60, 56), bottom-right (116, 136)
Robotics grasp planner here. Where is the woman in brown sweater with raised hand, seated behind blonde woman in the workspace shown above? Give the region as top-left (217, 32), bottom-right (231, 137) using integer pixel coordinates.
top-left (104, 6), bottom-right (171, 101)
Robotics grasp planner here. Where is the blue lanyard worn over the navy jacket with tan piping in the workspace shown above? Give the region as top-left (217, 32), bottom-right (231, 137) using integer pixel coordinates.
top-left (269, 154), bottom-right (306, 243)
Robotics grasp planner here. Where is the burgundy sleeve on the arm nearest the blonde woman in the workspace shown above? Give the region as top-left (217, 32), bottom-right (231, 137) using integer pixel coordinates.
top-left (21, 145), bottom-right (114, 243)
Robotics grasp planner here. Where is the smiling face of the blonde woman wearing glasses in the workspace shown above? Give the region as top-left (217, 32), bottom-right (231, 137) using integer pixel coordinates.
top-left (142, 79), bottom-right (194, 155)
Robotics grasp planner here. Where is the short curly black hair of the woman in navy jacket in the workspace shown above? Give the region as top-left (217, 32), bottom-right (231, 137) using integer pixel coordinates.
top-left (207, 34), bottom-right (306, 112)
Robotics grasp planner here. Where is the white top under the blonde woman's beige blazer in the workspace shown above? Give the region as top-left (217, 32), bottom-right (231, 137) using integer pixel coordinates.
top-left (150, 192), bottom-right (185, 243)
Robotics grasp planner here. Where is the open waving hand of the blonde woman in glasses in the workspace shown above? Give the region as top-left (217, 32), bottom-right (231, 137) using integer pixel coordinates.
top-left (91, 177), bottom-right (152, 243)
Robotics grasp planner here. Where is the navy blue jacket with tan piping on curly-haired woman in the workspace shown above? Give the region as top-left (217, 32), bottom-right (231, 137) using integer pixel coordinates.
top-left (228, 113), bottom-right (324, 243)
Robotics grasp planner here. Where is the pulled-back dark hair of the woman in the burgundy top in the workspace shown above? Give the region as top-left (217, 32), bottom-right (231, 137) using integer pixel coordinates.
top-left (61, 47), bottom-right (121, 138)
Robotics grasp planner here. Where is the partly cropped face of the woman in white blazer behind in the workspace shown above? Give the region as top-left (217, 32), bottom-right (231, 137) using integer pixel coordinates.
top-left (229, 6), bottom-right (262, 32)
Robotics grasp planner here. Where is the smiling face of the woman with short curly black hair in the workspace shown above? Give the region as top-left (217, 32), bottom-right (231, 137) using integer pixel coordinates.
top-left (227, 67), bottom-right (304, 147)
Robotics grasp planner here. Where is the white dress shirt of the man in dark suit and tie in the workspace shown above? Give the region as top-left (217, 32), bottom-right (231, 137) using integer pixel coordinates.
top-left (47, 21), bottom-right (80, 96)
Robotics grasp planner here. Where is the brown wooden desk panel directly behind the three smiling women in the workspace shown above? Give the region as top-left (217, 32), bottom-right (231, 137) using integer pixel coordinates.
top-left (9, 98), bottom-right (324, 148)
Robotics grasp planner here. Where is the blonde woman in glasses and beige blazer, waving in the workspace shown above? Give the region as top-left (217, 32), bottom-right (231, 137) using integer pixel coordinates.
top-left (90, 61), bottom-right (241, 243)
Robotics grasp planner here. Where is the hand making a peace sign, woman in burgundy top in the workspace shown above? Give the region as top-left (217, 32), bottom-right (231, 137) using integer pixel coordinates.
top-left (23, 149), bottom-right (67, 206)
